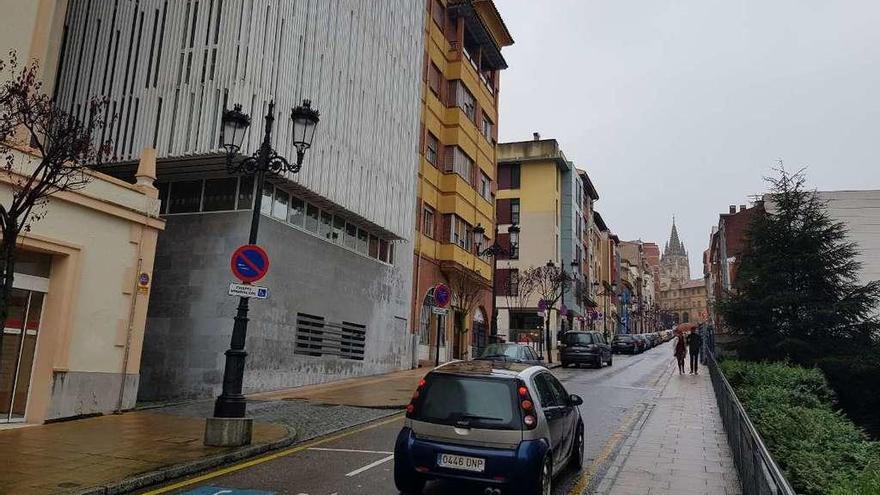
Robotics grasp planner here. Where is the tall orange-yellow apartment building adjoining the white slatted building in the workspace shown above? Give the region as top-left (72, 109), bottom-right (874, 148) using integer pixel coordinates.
top-left (412, 0), bottom-right (513, 361)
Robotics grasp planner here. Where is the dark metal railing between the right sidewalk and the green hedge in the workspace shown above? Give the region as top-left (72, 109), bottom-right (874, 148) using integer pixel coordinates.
top-left (707, 352), bottom-right (796, 495)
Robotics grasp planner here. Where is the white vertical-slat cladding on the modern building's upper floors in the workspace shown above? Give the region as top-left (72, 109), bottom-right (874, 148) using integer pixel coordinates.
top-left (57, 0), bottom-right (424, 239)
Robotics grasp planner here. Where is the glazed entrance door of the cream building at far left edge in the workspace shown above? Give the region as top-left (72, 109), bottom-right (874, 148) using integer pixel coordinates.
top-left (0, 273), bottom-right (49, 423)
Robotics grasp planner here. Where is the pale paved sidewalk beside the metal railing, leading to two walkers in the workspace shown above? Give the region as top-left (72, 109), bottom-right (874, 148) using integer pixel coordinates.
top-left (596, 362), bottom-right (741, 495)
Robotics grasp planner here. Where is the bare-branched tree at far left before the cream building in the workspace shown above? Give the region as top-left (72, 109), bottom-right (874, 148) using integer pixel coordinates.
top-left (0, 52), bottom-right (109, 354)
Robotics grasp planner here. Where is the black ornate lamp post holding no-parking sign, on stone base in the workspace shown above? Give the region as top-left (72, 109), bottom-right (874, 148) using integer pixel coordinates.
top-left (205, 100), bottom-right (319, 446)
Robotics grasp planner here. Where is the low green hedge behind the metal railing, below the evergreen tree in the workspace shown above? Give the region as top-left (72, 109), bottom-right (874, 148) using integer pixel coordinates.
top-left (720, 359), bottom-right (880, 495)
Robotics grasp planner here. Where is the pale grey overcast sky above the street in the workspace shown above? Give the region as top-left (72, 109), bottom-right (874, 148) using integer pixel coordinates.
top-left (496, 0), bottom-right (880, 277)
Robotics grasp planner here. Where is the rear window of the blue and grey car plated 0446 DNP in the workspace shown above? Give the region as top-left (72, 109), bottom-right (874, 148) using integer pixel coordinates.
top-left (411, 373), bottom-right (522, 430)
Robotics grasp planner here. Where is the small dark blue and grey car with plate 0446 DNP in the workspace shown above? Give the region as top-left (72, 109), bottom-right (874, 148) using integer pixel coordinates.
top-left (394, 360), bottom-right (584, 495)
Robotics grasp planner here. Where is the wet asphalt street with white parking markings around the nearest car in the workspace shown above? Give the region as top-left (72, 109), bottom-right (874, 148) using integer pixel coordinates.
top-left (141, 343), bottom-right (672, 495)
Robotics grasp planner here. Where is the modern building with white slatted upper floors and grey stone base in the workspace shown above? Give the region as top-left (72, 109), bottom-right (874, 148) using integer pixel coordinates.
top-left (56, 0), bottom-right (424, 400)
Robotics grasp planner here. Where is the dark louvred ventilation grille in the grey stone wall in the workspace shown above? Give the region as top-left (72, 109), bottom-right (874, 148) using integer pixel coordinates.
top-left (294, 313), bottom-right (367, 361)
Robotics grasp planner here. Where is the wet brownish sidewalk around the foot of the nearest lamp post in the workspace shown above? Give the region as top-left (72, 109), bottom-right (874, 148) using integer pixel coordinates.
top-left (0, 368), bottom-right (431, 495)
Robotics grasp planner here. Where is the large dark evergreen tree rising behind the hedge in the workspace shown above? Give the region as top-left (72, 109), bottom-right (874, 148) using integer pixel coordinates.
top-left (718, 169), bottom-right (880, 365)
